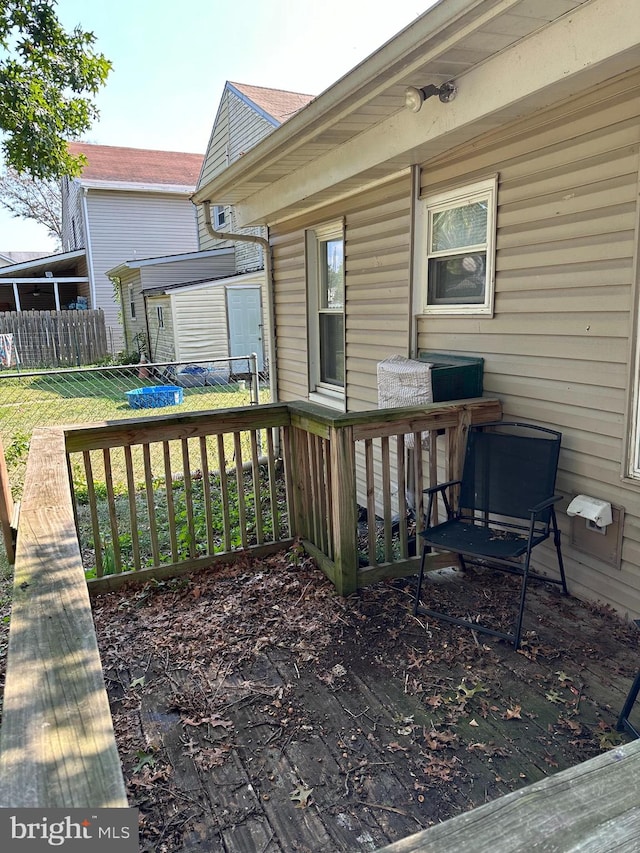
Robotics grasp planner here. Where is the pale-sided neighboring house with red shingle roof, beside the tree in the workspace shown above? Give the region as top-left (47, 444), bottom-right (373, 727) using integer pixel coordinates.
top-left (62, 142), bottom-right (202, 349)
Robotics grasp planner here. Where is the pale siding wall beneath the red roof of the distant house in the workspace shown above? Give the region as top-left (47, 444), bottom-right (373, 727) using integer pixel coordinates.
top-left (87, 190), bottom-right (198, 349)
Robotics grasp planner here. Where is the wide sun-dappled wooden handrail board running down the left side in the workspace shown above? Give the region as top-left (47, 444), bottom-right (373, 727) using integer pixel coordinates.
top-left (0, 428), bottom-right (127, 808)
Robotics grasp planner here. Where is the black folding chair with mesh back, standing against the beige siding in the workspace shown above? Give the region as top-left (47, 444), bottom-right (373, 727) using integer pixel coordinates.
top-left (414, 421), bottom-right (567, 649)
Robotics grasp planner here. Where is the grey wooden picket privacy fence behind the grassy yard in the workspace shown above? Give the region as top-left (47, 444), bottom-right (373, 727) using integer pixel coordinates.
top-left (0, 310), bottom-right (108, 367)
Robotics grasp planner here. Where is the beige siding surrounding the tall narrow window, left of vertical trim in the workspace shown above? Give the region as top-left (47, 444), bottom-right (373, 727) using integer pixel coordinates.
top-left (271, 177), bottom-right (410, 404)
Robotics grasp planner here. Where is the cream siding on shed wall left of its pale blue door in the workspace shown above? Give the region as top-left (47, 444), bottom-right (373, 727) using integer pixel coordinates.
top-left (171, 285), bottom-right (229, 363)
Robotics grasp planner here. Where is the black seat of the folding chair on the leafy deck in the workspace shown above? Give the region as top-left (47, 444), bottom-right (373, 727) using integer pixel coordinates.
top-left (420, 519), bottom-right (547, 560)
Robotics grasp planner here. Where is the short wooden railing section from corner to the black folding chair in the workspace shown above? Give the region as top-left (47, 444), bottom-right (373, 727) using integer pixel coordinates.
top-left (284, 399), bottom-right (502, 595)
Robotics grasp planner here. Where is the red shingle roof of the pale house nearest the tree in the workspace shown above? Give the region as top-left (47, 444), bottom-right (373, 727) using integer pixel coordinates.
top-left (69, 142), bottom-right (203, 188)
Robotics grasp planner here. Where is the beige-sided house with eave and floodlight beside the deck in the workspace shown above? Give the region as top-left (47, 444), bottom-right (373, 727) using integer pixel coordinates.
top-left (194, 0), bottom-right (640, 617)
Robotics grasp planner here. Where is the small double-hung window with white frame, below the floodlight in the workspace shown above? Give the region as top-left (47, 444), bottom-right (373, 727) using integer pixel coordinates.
top-left (421, 178), bottom-right (497, 315)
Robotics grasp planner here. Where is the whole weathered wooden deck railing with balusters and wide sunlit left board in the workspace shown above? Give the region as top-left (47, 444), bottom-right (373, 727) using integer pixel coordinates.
top-left (0, 400), bottom-right (500, 807)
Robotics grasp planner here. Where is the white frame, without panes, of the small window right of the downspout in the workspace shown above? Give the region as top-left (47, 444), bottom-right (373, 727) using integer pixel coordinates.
top-left (415, 175), bottom-right (498, 316)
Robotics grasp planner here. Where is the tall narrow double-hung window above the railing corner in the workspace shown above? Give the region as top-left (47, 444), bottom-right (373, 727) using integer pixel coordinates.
top-left (307, 221), bottom-right (345, 405)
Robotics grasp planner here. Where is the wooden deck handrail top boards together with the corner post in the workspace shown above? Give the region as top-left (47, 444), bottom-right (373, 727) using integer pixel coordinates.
top-left (0, 399), bottom-right (500, 808)
